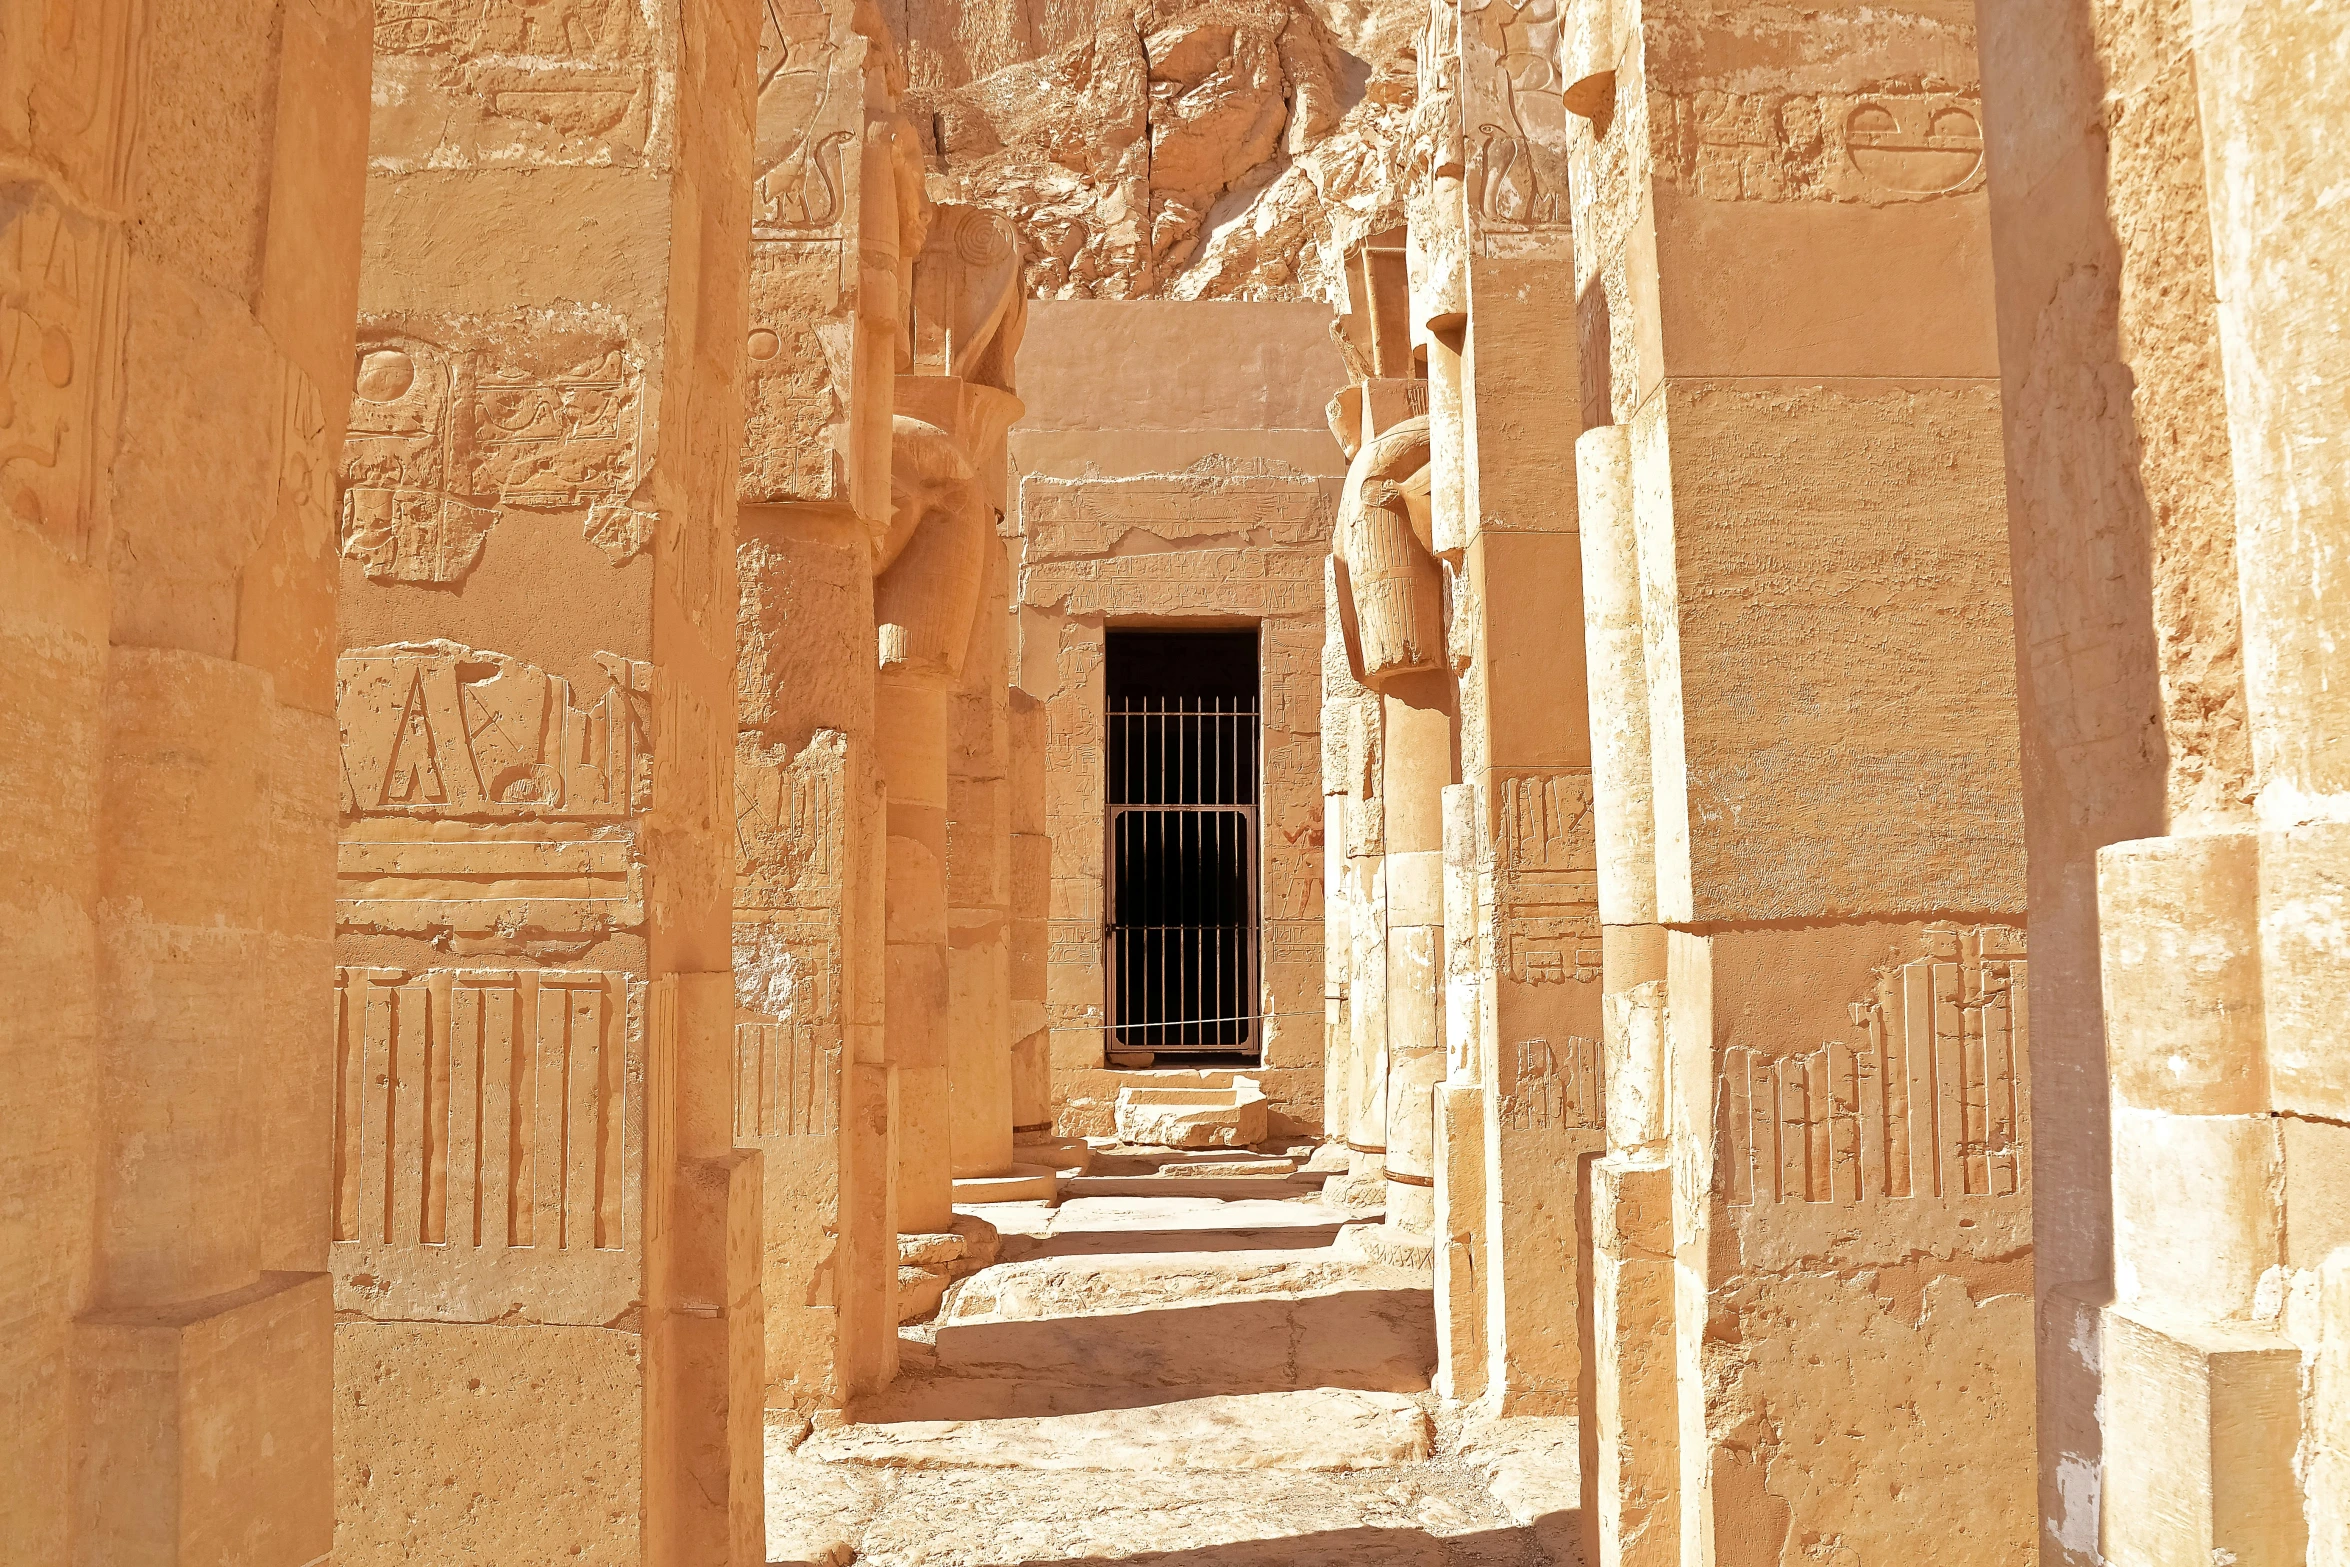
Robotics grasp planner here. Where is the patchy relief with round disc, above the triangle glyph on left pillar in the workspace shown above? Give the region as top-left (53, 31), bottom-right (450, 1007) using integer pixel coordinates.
top-left (343, 320), bottom-right (653, 583)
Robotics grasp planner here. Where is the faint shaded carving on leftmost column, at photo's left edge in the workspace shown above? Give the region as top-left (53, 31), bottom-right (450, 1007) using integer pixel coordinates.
top-left (0, 187), bottom-right (122, 557)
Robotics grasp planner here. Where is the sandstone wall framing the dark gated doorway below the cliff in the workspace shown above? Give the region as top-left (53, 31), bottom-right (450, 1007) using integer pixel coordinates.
top-left (1006, 303), bottom-right (1344, 1135)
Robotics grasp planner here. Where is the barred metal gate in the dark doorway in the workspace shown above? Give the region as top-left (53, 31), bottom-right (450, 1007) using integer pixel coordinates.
top-left (1102, 695), bottom-right (1260, 1055)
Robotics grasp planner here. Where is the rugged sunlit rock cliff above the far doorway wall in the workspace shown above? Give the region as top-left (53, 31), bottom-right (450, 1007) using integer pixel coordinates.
top-left (881, 0), bottom-right (1422, 298)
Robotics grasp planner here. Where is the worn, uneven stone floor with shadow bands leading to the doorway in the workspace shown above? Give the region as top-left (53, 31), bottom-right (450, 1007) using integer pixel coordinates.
top-left (766, 1146), bottom-right (1579, 1567)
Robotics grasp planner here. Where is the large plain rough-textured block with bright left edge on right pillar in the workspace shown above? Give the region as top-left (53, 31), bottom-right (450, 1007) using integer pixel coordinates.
top-left (1633, 385), bottom-right (2023, 923)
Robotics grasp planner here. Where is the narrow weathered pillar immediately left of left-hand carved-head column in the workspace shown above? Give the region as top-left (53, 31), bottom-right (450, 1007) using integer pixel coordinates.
top-left (733, 2), bottom-right (926, 1410)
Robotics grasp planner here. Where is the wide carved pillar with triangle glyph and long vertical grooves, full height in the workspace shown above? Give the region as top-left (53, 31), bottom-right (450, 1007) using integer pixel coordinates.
top-left (334, 0), bottom-right (764, 1562)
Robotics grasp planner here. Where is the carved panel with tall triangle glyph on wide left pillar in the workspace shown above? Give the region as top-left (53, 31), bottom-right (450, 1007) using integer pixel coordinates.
top-left (336, 641), bottom-right (653, 822)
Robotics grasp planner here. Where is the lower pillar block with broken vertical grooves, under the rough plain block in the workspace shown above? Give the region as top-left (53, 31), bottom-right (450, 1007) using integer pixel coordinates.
top-left (1669, 923), bottom-right (2035, 1560)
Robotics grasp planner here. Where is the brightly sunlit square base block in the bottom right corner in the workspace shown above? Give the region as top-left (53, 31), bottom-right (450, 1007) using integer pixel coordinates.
top-left (2101, 1306), bottom-right (2308, 1567)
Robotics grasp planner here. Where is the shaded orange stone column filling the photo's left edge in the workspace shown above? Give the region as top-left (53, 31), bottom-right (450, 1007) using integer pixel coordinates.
top-left (0, 0), bottom-right (367, 1567)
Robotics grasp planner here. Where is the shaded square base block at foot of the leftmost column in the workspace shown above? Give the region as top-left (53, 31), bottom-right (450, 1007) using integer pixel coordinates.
top-left (71, 1273), bottom-right (336, 1567)
